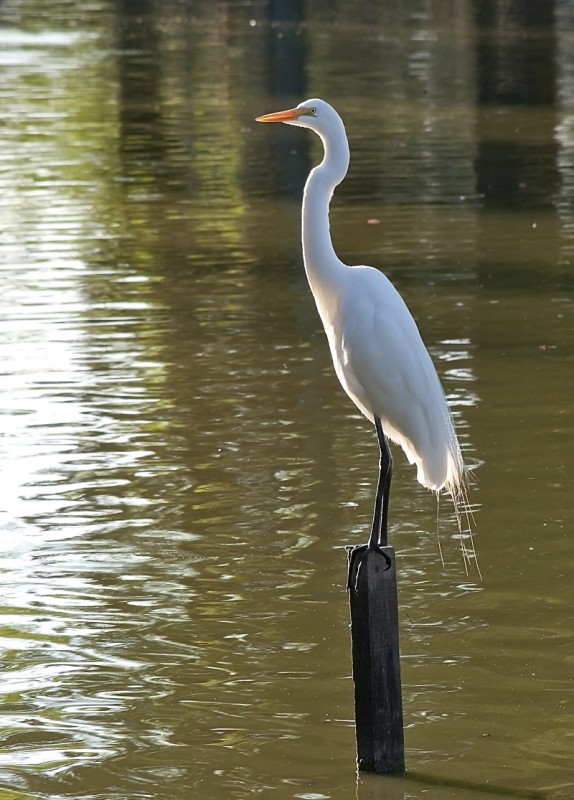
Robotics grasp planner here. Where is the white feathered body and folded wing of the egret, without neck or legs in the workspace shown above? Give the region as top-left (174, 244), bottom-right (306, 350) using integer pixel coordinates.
top-left (319, 267), bottom-right (464, 492)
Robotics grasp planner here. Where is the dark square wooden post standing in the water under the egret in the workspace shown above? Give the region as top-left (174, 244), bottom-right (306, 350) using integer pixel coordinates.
top-left (347, 546), bottom-right (405, 773)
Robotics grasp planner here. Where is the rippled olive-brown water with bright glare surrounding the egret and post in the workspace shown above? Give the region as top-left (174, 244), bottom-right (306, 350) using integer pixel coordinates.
top-left (0, 0), bottom-right (574, 800)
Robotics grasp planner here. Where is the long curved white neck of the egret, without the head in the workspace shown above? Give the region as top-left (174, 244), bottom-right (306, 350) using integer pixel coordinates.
top-left (302, 122), bottom-right (349, 300)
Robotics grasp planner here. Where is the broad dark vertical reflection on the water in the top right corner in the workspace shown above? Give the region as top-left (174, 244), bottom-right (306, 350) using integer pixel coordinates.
top-left (475, 0), bottom-right (558, 210)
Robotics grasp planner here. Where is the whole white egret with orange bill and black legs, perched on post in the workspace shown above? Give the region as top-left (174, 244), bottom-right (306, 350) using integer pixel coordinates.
top-left (257, 99), bottom-right (474, 580)
